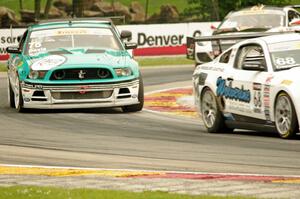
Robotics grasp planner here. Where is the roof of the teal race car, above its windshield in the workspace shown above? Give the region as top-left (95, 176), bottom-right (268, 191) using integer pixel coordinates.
top-left (28, 18), bottom-right (113, 30)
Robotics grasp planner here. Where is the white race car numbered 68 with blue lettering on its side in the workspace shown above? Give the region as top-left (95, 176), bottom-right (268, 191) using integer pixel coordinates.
top-left (193, 33), bottom-right (300, 138)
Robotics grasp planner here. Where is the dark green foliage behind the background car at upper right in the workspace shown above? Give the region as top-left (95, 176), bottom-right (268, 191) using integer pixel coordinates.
top-left (183, 0), bottom-right (291, 21)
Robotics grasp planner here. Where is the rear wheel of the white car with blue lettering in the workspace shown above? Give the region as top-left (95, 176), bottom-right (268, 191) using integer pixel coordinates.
top-left (200, 88), bottom-right (227, 133)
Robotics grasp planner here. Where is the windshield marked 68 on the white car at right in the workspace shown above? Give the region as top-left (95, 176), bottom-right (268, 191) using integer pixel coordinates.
top-left (269, 41), bottom-right (300, 70)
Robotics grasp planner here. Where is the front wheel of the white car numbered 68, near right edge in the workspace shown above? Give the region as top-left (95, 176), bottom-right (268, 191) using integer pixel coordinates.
top-left (274, 92), bottom-right (298, 139)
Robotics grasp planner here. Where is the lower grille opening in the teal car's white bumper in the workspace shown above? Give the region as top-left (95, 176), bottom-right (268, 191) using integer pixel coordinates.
top-left (51, 90), bottom-right (113, 100)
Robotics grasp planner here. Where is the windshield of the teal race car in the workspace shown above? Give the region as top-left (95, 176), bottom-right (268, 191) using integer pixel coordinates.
top-left (25, 28), bottom-right (122, 56)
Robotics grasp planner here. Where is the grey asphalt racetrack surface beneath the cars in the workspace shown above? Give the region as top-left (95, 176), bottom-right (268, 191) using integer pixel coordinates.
top-left (0, 66), bottom-right (300, 175)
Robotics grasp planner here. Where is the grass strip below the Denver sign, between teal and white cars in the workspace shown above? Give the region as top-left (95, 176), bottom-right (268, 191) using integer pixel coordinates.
top-left (136, 57), bottom-right (195, 67)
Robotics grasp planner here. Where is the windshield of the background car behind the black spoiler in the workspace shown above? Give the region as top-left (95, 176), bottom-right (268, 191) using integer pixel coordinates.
top-left (218, 11), bottom-right (284, 32)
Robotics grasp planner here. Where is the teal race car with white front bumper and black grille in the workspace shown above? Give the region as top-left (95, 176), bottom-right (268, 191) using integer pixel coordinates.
top-left (7, 18), bottom-right (144, 112)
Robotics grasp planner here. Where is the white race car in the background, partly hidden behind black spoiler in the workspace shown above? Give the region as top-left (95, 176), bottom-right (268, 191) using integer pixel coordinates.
top-left (189, 5), bottom-right (300, 65)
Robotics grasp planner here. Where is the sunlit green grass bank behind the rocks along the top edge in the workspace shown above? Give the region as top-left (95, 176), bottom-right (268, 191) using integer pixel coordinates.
top-left (0, 0), bottom-right (188, 16)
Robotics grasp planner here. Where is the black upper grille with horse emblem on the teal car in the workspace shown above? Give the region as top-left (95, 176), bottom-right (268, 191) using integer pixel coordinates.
top-left (50, 68), bottom-right (113, 80)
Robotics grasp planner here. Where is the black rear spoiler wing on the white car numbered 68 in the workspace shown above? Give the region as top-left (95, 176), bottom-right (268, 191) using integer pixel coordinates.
top-left (186, 31), bottom-right (297, 59)
